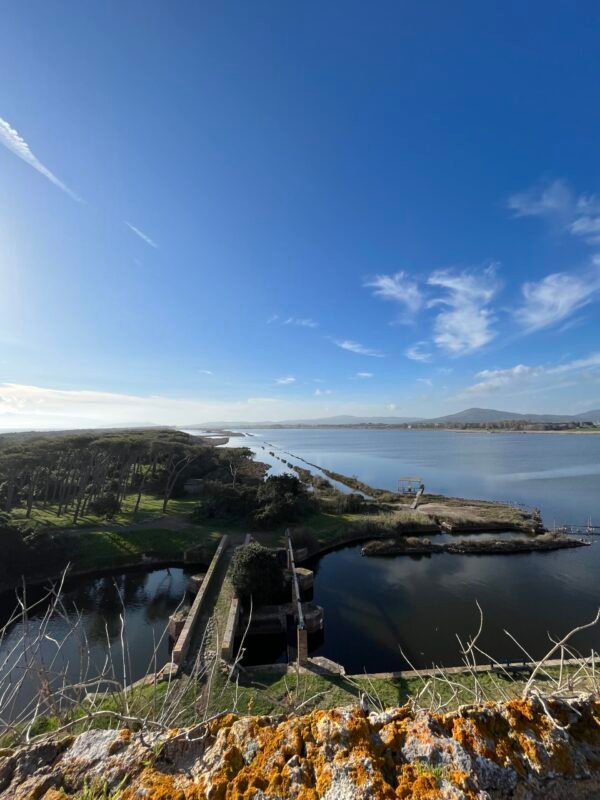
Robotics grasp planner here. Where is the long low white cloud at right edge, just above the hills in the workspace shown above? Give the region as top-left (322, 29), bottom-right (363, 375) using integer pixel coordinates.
top-left (462, 353), bottom-right (600, 396)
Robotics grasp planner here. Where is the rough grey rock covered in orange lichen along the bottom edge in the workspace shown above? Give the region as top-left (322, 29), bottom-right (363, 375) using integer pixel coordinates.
top-left (0, 697), bottom-right (600, 800)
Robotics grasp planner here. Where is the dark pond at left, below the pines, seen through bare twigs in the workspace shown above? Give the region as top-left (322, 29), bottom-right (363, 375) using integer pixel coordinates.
top-left (0, 568), bottom-right (187, 718)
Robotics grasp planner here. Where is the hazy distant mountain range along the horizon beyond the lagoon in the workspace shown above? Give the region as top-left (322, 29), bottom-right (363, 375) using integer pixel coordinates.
top-left (187, 408), bottom-right (600, 429)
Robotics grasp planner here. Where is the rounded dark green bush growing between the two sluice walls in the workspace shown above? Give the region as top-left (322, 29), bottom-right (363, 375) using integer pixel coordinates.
top-left (231, 542), bottom-right (284, 605)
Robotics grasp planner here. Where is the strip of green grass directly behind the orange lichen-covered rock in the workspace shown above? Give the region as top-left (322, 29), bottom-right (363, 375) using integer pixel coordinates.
top-left (0, 665), bottom-right (593, 747)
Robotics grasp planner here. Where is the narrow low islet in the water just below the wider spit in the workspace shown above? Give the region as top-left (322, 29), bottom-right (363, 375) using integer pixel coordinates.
top-left (361, 533), bottom-right (589, 556)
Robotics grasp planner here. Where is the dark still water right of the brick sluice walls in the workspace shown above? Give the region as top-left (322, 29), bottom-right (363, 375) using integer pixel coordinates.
top-left (312, 546), bottom-right (600, 672)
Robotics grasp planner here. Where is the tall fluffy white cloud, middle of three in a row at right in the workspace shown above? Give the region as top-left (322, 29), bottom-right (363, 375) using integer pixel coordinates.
top-left (427, 265), bottom-right (498, 356)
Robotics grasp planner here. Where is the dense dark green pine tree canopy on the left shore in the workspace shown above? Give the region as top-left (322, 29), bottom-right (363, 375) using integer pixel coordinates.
top-left (0, 429), bottom-right (255, 525)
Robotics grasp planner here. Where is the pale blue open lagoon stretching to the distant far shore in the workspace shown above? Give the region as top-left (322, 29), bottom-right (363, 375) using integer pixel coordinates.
top-left (239, 429), bottom-right (600, 526)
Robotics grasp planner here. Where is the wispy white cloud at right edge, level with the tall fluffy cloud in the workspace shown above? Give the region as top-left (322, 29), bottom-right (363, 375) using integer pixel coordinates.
top-left (515, 263), bottom-right (600, 331)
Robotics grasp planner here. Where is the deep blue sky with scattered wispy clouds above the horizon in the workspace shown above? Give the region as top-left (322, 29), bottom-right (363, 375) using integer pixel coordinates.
top-left (0, 0), bottom-right (600, 428)
